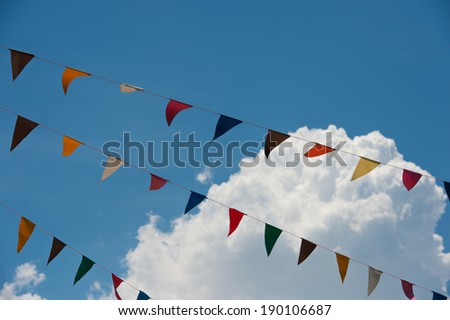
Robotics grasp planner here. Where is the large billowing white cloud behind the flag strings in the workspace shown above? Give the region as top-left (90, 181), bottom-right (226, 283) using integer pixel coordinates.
top-left (126, 126), bottom-right (450, 299)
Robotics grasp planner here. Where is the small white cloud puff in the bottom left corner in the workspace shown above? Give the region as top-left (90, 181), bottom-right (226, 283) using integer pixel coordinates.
top-left (0, 262), bottom-right (45, 300)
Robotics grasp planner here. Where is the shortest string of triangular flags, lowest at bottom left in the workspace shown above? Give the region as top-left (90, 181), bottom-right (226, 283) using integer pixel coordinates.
top-left (0, 200), bottom-right (151, 300)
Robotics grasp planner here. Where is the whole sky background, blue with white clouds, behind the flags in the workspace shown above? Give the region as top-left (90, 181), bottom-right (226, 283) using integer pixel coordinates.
top-left (0, 0), bottom-right (450, 299)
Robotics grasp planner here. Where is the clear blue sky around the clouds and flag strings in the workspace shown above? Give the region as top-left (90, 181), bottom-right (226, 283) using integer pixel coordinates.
top-left (0, 1), bottom-right (450, 299)
